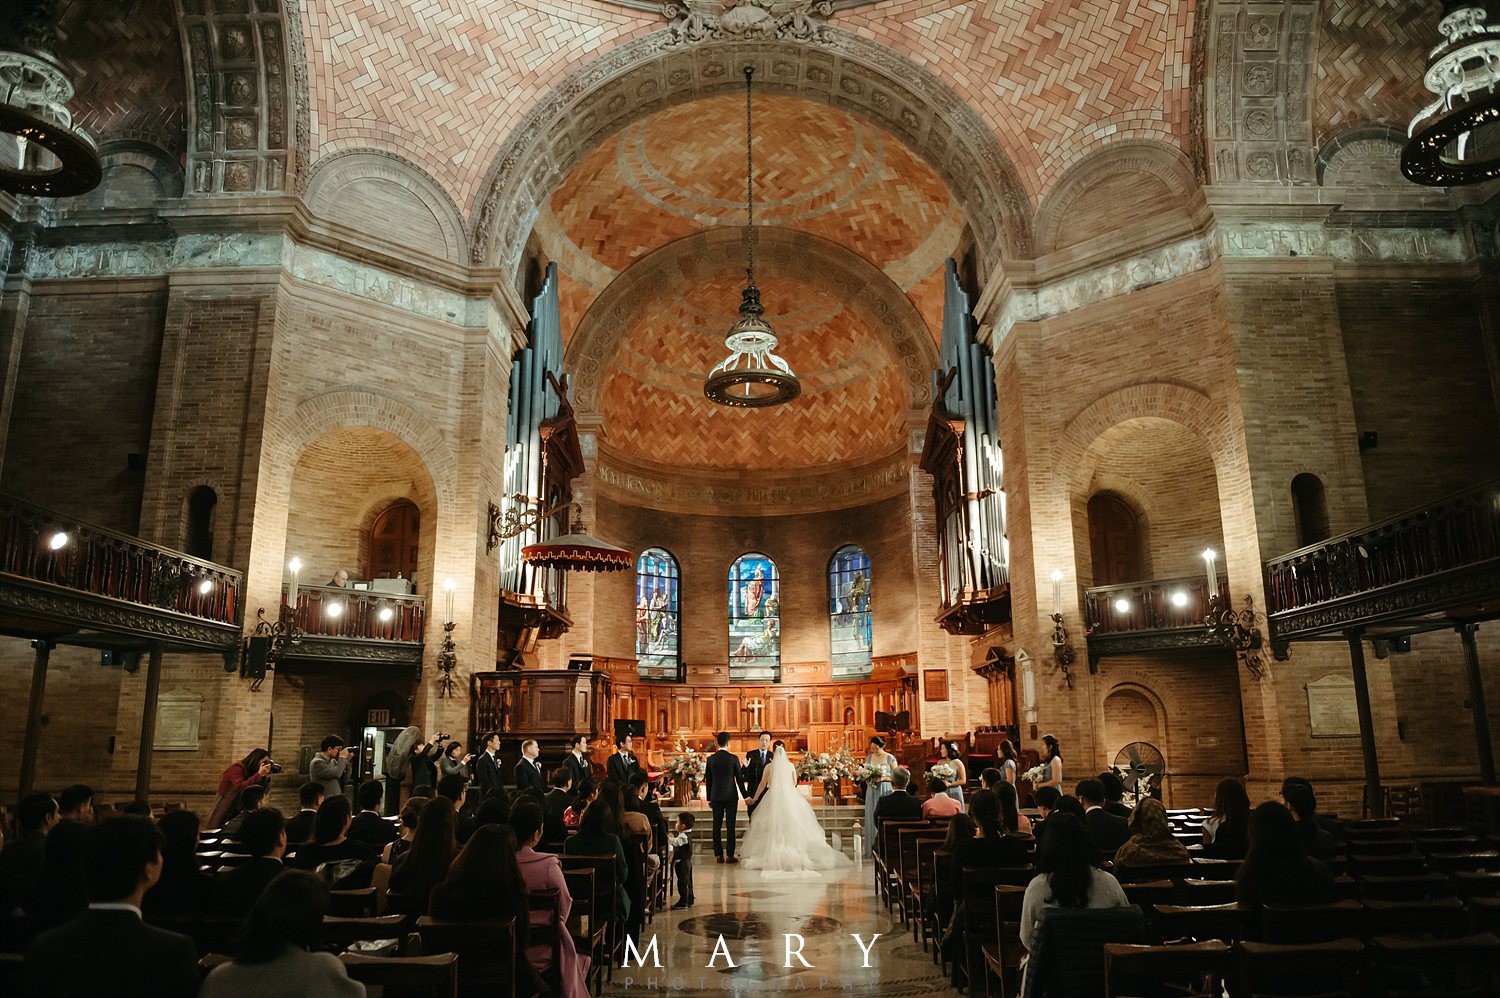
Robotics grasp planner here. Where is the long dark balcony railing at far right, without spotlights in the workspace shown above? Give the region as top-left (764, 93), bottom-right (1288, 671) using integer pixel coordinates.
top-left (1266, 479), bottom-right (1500, 642)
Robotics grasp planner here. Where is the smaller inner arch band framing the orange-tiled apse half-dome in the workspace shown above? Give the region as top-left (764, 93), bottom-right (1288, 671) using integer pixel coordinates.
top-left (567, 227), bottom-right (938, 414)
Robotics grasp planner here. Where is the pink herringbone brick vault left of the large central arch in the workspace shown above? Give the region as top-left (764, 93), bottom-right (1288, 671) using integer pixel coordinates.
top-left (302, 0), bottom-right (662, 209)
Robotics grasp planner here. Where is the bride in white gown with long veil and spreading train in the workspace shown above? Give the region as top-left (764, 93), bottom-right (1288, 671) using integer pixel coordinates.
top-left (740, 741), bottom-right (852, 878)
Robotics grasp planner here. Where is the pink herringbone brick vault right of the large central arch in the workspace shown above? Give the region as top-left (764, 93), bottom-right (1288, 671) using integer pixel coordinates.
top-left (836, 0), bottom-right (1199, 200)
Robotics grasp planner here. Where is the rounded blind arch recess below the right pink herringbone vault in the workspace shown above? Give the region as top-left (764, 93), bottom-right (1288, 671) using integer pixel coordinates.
top-left (1034, 140), bottom-right (1203, 254)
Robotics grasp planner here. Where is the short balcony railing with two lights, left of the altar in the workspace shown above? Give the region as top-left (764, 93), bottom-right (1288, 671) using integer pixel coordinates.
top-left (282, 585), bottom-right (428, 666)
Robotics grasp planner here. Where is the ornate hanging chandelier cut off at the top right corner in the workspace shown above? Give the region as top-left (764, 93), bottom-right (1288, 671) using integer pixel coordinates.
top-left (1401, 0), bottom-right (1500, 188)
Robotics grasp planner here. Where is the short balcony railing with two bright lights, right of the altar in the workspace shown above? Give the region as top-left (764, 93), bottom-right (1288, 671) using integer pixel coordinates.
top-left (1083, 575), bottom-right (1229, 671)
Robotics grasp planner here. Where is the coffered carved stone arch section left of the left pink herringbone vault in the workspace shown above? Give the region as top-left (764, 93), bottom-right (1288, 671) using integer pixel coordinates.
top-left (176, 0), bottom-right (311, 194)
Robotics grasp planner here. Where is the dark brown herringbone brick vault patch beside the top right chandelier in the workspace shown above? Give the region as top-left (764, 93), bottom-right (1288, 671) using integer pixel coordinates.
top-left (1313, 0), bottom-right (1443, 143)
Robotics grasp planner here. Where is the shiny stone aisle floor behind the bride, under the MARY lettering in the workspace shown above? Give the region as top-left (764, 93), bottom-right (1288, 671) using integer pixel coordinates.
top-left (605, 855), bottom-right (953, 998)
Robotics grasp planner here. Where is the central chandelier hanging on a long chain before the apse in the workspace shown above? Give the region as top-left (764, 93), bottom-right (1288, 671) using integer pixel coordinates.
top-left (704, 66), bottom-right (803, 408)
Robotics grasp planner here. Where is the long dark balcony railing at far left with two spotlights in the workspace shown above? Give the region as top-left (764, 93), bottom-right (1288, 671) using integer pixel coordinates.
top-left (0, 497), bottom-right (243, 648)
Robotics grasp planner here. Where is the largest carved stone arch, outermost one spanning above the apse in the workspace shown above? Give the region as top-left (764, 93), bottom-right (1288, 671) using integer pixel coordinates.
top-left (470, 29), bottom-right (1031, 273)
